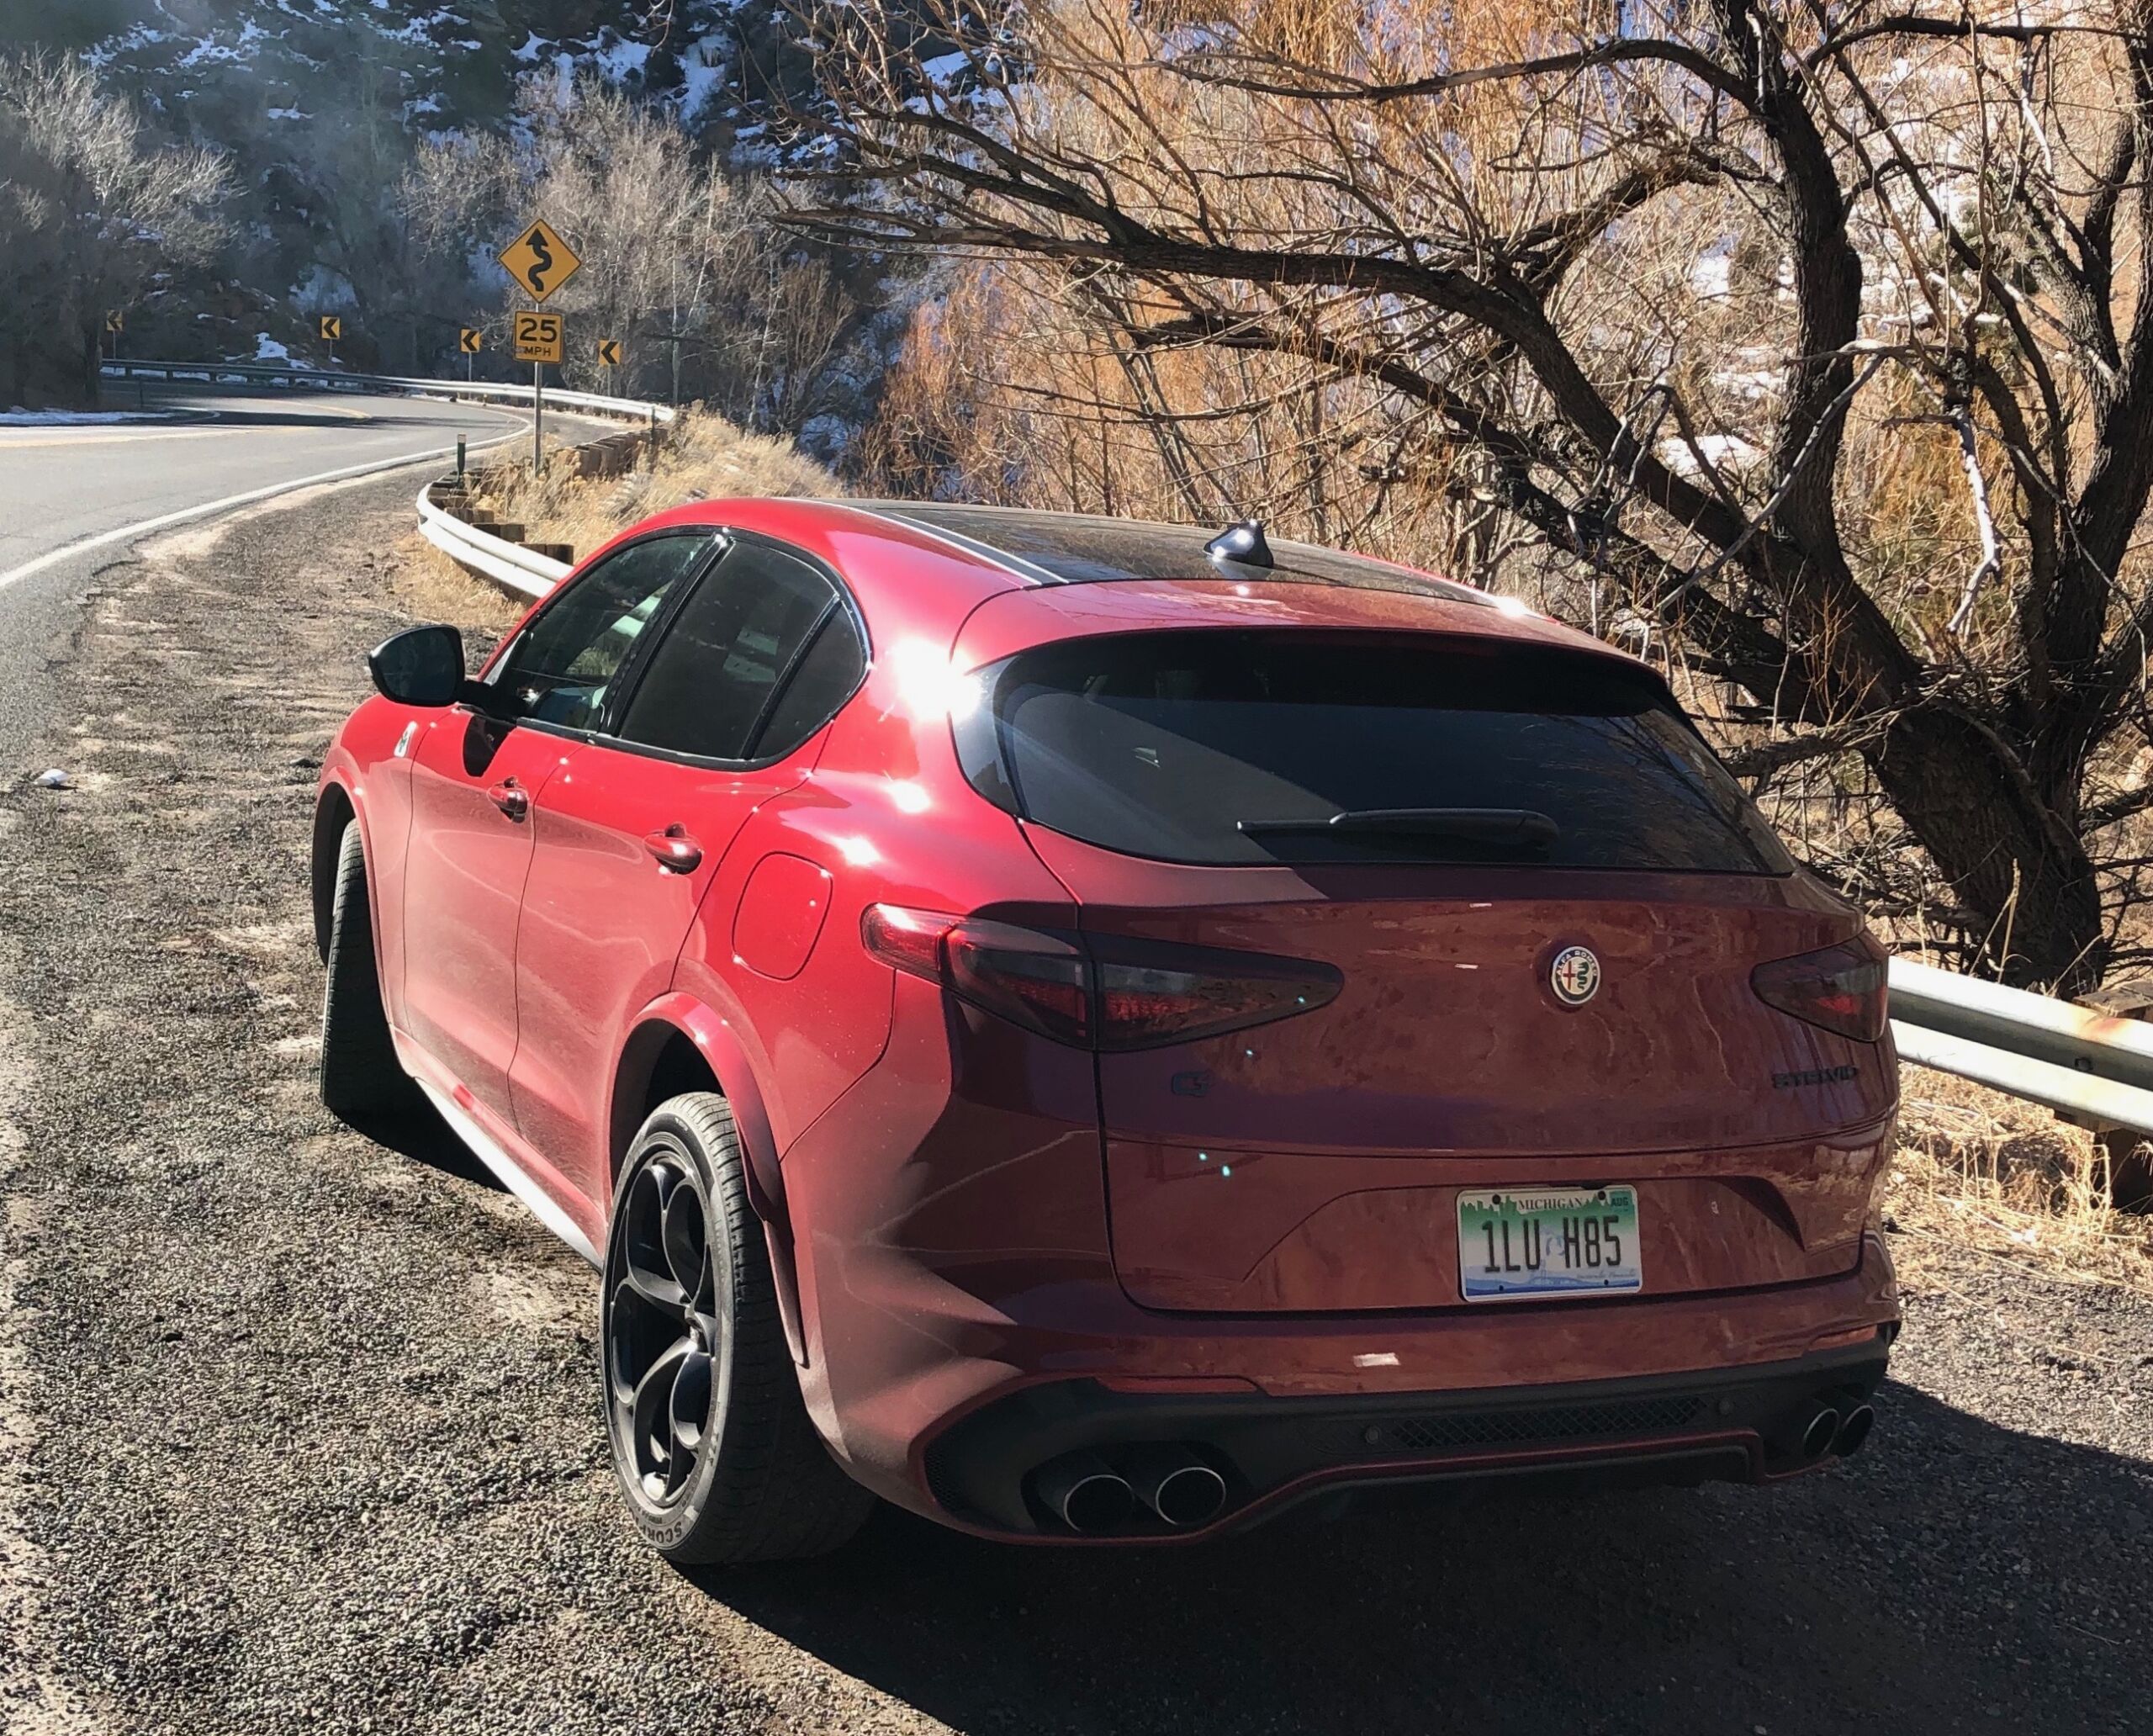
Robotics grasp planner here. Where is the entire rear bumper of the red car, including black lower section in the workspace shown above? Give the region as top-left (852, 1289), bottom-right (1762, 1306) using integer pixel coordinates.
top-left (803, 1236), bottom-right (1899, 1543)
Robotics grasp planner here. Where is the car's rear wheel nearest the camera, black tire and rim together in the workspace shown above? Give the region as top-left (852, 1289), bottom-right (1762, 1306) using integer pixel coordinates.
top-left (599, 1092), bottom-right (874, 1566)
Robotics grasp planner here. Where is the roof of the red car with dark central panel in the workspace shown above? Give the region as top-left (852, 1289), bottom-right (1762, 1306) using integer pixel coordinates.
top-left (637, 498), bottom-right (1634, 661)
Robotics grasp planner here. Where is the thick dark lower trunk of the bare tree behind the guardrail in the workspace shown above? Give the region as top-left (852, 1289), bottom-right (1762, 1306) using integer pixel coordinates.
top-left (1869, 702), bottom-right (2110, 995)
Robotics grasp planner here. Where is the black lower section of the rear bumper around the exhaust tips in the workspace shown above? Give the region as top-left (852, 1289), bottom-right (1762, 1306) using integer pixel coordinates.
top-left (923, 1337), bottom-right (1886, 1543)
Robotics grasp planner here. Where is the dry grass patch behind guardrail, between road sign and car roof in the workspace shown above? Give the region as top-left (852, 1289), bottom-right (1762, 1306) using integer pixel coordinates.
top-left (480, 410), bottom-right (844, 556)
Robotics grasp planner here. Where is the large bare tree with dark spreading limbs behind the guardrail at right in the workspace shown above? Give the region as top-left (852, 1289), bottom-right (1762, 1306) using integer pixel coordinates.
top-left (795, 0), bottom-right (2153, 987)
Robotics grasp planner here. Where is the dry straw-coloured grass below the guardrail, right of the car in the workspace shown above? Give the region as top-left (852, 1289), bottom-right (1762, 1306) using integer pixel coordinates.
top-left (1884, 1066), bottom-right (2153, 1292)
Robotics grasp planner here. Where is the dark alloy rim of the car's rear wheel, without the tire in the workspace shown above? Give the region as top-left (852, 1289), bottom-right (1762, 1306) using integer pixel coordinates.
top-left (605, 1146), bottom-right (732, 1508)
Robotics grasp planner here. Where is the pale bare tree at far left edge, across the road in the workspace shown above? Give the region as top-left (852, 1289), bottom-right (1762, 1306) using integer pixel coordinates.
top-left (0, 54), bottom-right (228, 399)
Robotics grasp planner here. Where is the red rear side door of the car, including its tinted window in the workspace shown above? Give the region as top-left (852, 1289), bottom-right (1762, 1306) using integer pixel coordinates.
top-left (515, 537), bottom-right (861, 1213)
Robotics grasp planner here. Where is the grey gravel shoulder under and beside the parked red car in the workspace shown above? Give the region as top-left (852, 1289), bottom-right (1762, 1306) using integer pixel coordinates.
top-left (0, 480), bottom-right (2153, 1736)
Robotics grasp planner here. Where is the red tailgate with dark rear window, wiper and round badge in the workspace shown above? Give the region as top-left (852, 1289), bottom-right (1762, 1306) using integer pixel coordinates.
top-left (951, 629), bottom-right (1892, 1307)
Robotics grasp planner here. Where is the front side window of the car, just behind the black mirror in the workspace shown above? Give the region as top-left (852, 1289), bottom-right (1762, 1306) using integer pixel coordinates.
top-left (497, 534), bottom-right (712, 730)
